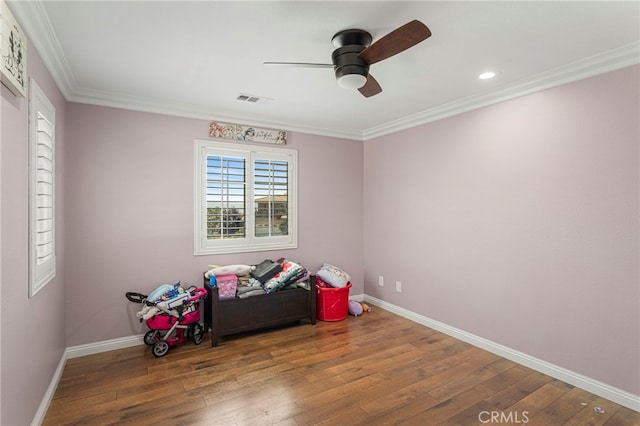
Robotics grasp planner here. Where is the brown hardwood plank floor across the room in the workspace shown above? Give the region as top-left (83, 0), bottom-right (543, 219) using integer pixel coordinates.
top-left (44, 307), bottom-right (640, 426)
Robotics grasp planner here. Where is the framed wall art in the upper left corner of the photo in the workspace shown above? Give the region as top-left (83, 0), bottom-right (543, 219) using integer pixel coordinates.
top-left (0, 0), bottom-right (27, 97)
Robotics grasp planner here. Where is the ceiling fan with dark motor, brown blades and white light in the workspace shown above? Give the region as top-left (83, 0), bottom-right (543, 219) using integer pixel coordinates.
top-left (264, 20), bottom-right (431, 98)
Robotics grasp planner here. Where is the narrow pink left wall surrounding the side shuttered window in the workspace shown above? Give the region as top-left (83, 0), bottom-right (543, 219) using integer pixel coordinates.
top-left (0, 42), bottom-right (67, 425)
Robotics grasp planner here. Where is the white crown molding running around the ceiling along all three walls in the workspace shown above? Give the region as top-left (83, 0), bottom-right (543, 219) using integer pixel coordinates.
top-left (11, 0), bottom-right (640, 141)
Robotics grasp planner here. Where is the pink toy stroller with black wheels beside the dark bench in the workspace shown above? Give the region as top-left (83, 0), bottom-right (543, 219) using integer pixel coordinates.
top-left (126, 283), bottom-right (207, 357)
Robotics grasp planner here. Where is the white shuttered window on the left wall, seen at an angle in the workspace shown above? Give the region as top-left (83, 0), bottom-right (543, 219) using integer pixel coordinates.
top-left (29, 79), bottom-right (56, 297)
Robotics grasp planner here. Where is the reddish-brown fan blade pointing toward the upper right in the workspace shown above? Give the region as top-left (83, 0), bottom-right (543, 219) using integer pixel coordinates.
top-left (358, 20), bottom-right (431, 65)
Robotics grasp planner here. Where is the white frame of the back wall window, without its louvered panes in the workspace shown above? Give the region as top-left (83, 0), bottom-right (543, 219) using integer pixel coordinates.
top-left (194, 139), bottom-right (298, 256)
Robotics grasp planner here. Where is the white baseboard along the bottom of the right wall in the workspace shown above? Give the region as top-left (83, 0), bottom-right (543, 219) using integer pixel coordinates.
top-left (364, 295), bottom-right (640, 412)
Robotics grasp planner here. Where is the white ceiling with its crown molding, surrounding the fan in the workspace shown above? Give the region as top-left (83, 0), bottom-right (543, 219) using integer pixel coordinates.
top-left (7, 1), bottom-right (640, 140)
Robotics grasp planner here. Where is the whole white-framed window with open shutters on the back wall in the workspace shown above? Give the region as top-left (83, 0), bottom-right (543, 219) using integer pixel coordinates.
top-left (194, 140), bottom-right (298, 255)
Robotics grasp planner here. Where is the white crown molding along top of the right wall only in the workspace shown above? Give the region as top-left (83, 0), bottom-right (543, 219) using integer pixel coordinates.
top-left (363, 41), bottom-right (640, 141)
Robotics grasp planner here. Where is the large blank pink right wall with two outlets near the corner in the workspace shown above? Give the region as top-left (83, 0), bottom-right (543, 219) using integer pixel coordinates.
top-left (364, 67), bottom-right (640, 395)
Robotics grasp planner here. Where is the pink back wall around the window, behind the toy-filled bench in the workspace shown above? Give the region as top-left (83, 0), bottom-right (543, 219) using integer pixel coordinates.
top-left (65, 103), bottom-right (363, 346)
